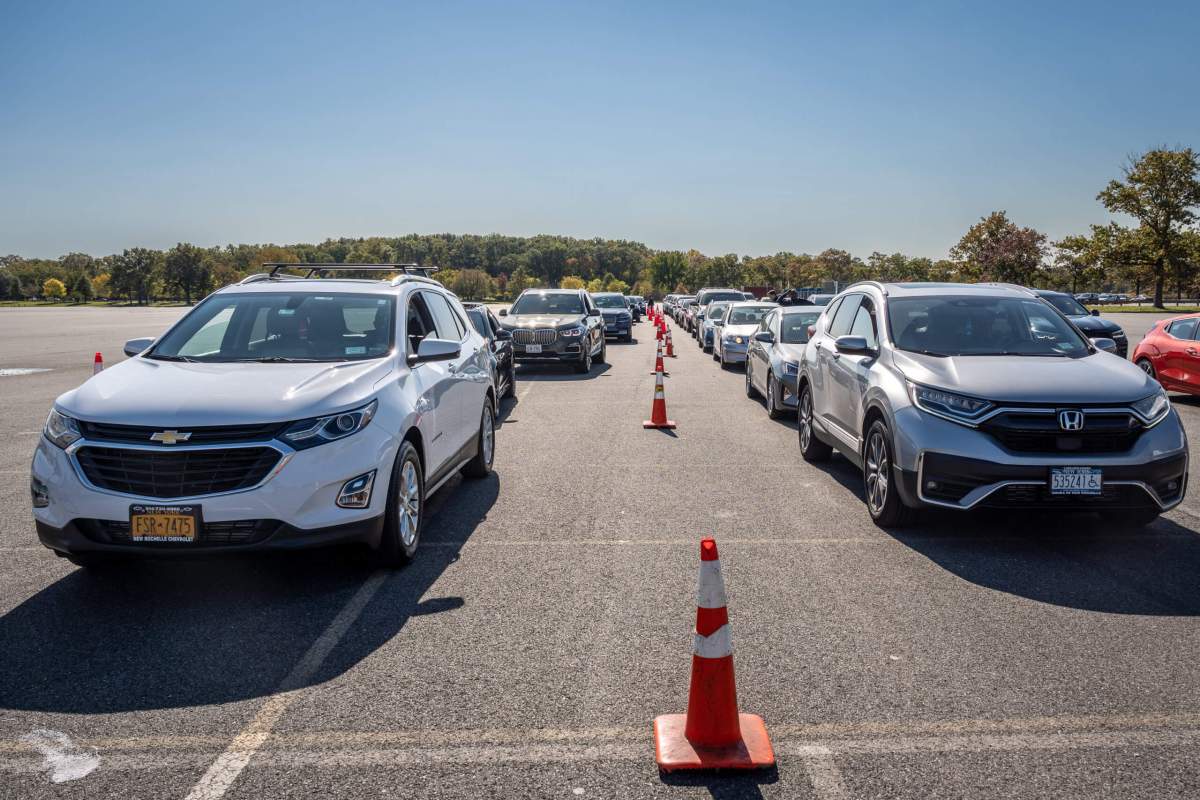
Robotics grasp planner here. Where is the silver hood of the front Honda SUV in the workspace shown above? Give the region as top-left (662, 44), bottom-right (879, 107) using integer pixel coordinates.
top-left (893, 350), bottom-right (1158, 405)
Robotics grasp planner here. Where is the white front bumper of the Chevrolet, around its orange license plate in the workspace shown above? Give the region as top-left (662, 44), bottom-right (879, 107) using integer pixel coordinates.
top-left (30, 425), bottom-right (398, 553)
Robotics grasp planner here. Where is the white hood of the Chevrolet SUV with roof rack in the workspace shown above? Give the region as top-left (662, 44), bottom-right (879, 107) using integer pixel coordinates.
top-left (55, 359), bottom-right (395, 428)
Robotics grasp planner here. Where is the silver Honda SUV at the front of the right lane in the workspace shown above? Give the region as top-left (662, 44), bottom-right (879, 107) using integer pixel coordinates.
top-left (798, 283), bottom-right (1188, 525)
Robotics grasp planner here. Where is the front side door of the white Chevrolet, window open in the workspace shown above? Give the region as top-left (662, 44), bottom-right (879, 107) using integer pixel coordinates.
top-left (403, 291), bottom-right (458, 477)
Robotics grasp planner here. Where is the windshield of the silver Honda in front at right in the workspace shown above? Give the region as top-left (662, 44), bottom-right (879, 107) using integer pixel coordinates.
top-left (888, 296), bottom-right (1090, 356)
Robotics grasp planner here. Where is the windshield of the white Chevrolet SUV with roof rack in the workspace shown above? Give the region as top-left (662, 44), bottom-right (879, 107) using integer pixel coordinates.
top-left (146, 291), bottom-right (396, 362)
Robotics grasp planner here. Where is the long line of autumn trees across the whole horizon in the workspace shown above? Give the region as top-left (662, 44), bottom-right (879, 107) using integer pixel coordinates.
top-left (0, 148), bottom-right (1200, 306)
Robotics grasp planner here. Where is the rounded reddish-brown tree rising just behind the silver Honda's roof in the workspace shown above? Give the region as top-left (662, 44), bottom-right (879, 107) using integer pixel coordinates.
top-left (950, 211), bottom-right (1046, 285)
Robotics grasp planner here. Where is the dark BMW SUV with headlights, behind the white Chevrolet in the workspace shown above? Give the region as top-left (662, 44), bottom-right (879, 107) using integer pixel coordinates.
top-left (500, 289), bottom-right (606, 373)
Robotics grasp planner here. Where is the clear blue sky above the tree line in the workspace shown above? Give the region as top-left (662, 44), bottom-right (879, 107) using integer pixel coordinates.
top-left (0, 0), bottom-right (1200, 257)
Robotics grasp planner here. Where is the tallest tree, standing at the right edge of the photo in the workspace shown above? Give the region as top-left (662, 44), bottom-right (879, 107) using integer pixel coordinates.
top-left (1096, 148), bottom-right (1200, 308)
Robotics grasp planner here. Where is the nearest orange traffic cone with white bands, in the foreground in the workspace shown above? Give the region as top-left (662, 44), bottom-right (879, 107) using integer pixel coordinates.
top-left (654, 539), bottom-right (775, 772)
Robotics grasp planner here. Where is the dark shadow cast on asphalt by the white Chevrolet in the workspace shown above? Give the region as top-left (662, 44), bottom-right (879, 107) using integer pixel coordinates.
top-left (0, 474), bottom-right (499, 714)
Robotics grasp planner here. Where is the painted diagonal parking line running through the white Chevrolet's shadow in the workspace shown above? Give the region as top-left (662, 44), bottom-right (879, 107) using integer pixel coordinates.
top-left (187, 570), bottom-right (390, 800)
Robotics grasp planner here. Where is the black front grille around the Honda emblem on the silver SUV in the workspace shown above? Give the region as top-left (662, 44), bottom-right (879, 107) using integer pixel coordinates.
top-left (980, 411), bottom-right (1144, 453)
